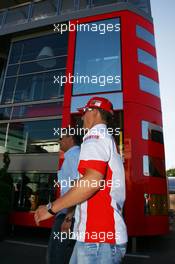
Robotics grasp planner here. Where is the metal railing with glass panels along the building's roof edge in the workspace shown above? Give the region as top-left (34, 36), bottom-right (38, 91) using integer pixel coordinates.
top-left (0, 0), bottom-right (151, 30)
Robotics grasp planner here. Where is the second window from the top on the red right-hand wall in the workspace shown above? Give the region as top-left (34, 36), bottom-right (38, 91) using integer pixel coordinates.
top-left (138, 49), bottom-right (157, 71)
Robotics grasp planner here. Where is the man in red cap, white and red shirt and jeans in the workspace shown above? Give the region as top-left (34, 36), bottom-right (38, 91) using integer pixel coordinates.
top-left (35, 97), bottom-right (127, 264)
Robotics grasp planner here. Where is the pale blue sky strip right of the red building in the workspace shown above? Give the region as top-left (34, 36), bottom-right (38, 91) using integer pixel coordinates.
top-left (151, 0), bottom-right (175, 169)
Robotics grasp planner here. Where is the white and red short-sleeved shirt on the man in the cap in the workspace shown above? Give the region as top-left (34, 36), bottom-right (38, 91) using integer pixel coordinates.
top-left (74, 124), bottom-right (127, 244)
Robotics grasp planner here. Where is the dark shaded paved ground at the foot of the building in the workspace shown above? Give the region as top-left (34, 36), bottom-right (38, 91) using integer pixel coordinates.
top-left (0, 228), bottom-right (175, 264)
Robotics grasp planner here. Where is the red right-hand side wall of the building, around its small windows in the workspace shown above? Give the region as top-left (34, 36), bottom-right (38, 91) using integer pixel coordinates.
top-left (121, 12), bottom-right (168, 236)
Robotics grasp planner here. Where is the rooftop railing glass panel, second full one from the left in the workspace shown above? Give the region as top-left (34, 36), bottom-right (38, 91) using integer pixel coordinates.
top-left (32, 0), bottom-right (58, 20)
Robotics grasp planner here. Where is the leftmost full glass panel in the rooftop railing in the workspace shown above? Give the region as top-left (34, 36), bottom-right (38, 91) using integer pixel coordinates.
top-left (4, 5), bottom-right (29, 26)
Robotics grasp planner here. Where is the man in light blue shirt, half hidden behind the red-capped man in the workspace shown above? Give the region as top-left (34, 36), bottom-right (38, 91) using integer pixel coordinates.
top-left (47, 128), bottom-right (80, 264)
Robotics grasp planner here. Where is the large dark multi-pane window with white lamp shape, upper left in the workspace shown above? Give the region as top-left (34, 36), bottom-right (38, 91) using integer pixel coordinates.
top-left (1, 32), bottom-right (68, 104)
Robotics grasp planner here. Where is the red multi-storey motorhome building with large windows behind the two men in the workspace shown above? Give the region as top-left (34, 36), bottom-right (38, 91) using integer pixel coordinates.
top-left (0, 0), bottom-right (168, 236)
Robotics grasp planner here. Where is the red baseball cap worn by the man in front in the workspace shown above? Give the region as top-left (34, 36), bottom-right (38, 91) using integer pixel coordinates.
top-left (78, 97), bottom-right (114, 114)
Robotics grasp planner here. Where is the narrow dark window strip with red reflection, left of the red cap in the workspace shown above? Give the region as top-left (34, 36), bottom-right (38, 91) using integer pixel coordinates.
top-left (12, 102), bottom-right (63, 119)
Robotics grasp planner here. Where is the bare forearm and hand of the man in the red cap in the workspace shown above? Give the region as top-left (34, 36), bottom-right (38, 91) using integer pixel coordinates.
top-left (35, 169), bottom-right (104, 225)
